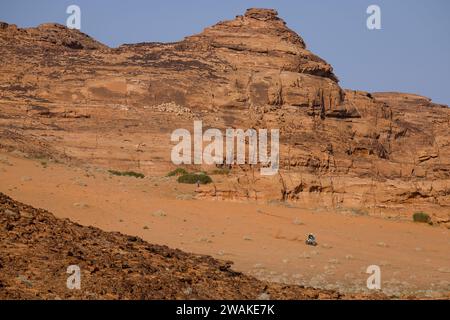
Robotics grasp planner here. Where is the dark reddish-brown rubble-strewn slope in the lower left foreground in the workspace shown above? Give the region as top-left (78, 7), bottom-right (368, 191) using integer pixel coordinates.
top-left (0, 193), bottom-right (383, 299)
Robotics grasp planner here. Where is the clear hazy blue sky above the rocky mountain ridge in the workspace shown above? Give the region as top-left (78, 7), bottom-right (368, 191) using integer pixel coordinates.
top-left (0, 0), bottom-right (450, 104)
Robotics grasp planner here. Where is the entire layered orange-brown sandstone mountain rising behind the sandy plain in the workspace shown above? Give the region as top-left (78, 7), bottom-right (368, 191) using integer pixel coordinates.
top-left (0, 9), bottom-right (450, 223)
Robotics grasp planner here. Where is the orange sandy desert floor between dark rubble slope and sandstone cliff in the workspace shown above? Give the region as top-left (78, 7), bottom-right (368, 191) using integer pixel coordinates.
top-left (0, 153), bottom-right (450, 298)
